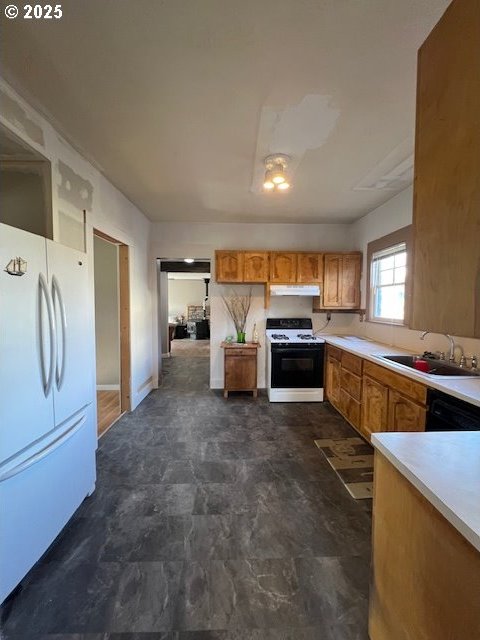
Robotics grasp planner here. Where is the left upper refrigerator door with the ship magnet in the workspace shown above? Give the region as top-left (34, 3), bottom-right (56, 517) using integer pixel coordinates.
top-left (0, 224), bottom-right (55, 463)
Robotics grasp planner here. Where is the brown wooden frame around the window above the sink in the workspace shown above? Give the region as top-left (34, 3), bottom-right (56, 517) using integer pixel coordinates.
top-left (366, 225), bottom-right (413, 327)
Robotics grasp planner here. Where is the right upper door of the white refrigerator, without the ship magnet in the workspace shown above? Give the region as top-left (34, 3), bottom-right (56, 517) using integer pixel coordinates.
top-left (47, 240), bottom-right (95, 425)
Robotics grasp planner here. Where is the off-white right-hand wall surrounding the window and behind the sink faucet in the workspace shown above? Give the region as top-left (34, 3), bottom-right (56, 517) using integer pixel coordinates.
top-left (351, 187), bottom-right (480, 359)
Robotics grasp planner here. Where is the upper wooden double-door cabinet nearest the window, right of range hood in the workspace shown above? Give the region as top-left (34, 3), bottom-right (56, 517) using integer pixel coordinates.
top-left (314, 253), bottom-right (362, 309)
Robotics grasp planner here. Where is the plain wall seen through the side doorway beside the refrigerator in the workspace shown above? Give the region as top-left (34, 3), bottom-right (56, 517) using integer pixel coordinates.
top-left (94, 236), bottom-right (120, 389)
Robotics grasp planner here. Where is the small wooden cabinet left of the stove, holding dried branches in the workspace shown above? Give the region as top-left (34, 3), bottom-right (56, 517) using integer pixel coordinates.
top-left (221, 342), bottom-right (260, 398)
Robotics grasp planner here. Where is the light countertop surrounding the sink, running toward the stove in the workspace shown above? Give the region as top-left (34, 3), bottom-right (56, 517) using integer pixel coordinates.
top-left (321, 334), bottom-right (480, 407)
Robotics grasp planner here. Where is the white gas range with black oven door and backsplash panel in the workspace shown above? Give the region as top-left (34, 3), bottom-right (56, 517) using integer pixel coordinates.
top-left (266, 318), bottom-right (325, 402)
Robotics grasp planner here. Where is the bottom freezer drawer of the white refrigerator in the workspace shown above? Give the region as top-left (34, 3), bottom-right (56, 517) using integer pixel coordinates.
top-left (0, 406), bottom-right (96, 604)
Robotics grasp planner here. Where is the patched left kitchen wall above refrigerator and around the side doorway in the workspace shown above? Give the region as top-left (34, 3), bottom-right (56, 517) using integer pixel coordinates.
top-left (0, 78), bottom-right (157, 407)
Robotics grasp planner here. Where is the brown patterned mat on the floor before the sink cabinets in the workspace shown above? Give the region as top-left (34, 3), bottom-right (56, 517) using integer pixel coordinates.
top-left (314, 438), bottom-right (373, 500)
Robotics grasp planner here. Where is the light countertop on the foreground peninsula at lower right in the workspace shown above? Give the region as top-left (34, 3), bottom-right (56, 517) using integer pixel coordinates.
top-left (372, 431), bottom-right (480, 551)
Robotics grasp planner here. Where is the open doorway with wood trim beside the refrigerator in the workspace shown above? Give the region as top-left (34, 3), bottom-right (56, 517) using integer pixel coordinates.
top-left (93, 229), bottom-right (131, 437)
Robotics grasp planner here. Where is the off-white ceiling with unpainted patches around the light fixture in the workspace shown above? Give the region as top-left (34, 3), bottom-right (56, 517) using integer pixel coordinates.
top-left (1, 0), bottom-right (449, 222)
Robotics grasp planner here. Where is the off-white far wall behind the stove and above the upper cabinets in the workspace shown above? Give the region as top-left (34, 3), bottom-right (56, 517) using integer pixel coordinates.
top-left (152, 222), bottom-right (354, 389)
